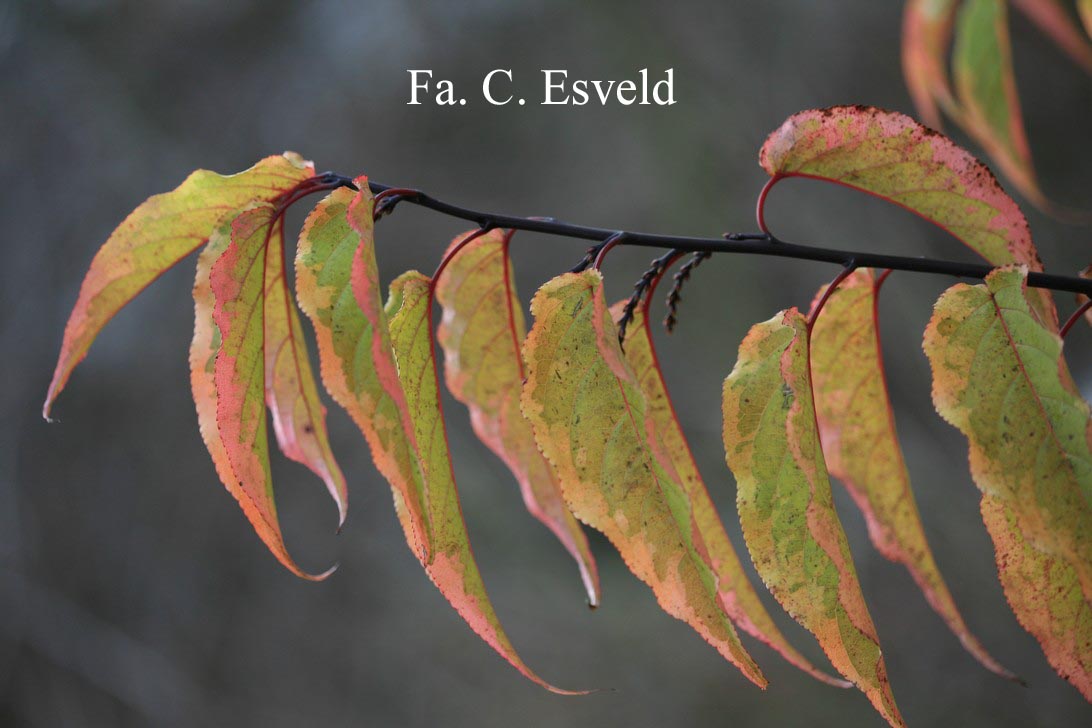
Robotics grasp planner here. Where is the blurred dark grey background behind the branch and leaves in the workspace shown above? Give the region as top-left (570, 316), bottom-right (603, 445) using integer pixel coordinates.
top-left (0, 0), bottom-right (1092, 727)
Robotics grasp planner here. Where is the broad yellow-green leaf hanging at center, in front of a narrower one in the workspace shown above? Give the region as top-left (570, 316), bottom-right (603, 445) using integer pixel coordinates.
top-left (522, 270), bottom-right (767, 688)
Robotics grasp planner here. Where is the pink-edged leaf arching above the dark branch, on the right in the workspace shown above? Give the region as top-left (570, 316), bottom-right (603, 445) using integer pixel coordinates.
top-left (759, 106), bottom-right (1057, 325)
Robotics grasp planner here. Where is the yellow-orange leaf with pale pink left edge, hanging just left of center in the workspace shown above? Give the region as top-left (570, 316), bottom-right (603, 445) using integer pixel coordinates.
top-left (436, 230), bottom-right (600, 607)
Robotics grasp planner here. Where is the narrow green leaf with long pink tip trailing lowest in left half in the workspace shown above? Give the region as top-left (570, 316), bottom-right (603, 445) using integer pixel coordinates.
top-left (384, 271), bottom-right (579, 694)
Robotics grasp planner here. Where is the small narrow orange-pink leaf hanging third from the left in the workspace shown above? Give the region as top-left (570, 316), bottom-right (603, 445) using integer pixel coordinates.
top-left (264, 224), bottom-right (348, 527)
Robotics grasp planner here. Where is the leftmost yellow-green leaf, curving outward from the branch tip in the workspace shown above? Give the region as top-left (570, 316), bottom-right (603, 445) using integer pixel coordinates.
top-left (41, 152), bottom-right (314, 419)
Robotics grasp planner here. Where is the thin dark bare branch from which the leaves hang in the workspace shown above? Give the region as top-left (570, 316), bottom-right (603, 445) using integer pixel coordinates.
top-left (322, 172), bottom-right (1092, 296)
